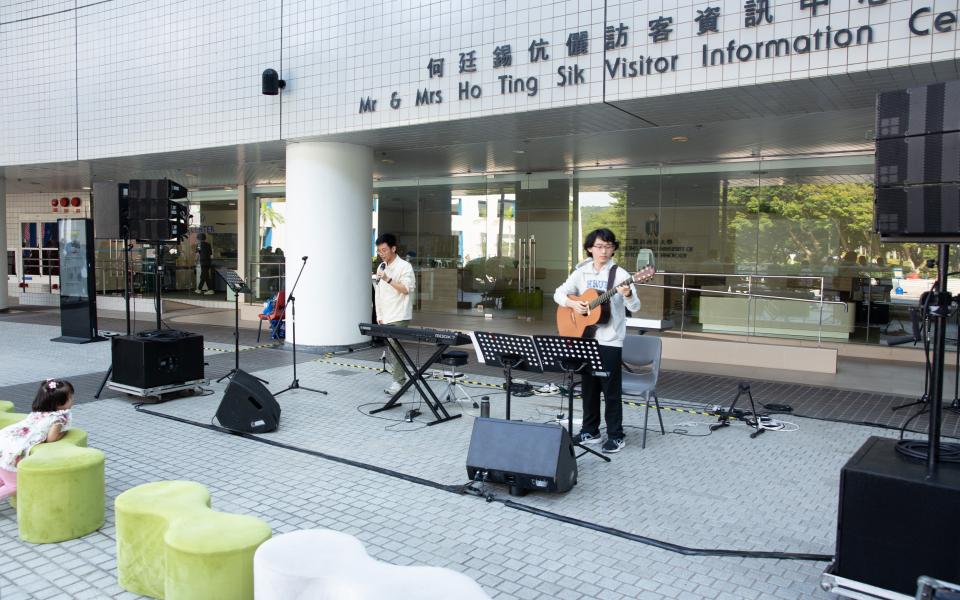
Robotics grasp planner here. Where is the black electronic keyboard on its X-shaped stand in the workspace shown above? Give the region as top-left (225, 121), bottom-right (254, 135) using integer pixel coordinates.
top-left (360, 323), bottom-right (470, 425)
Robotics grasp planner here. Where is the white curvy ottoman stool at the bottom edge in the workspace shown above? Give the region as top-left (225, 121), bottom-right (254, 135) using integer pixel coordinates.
top-left (253, 529), bottom-right (490, 600)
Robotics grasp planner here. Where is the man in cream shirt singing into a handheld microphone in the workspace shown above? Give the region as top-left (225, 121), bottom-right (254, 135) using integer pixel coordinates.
top-left (373, 233), bottom-right (417, 396)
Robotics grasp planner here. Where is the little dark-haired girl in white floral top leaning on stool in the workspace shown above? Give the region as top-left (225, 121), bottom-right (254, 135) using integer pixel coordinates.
top-left (0, 379), bottom-right (73, 499)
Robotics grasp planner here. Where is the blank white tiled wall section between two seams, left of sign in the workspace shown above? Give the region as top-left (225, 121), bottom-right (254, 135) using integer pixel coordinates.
top-left (77, 0), bottom-right (280, 159)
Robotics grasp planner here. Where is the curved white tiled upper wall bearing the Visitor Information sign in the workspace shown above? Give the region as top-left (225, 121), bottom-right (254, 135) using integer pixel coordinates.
top-left (0, 0), bottom-right (960, 164)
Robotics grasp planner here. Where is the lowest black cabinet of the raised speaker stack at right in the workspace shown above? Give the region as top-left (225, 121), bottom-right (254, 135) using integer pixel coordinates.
top-left (874, 184), bottom-right (960, 242)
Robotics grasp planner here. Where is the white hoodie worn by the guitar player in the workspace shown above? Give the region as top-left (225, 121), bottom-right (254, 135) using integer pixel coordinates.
top-left (553, 259), bottom-right (640, 347)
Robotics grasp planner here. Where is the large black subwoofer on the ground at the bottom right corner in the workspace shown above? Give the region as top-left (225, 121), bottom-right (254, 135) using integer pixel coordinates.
top-left (834, 437), bottom-right (960, 598)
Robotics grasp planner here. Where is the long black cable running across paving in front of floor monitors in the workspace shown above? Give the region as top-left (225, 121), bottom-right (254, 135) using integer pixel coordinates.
top-left (134, 404), bottom-right (833, 562)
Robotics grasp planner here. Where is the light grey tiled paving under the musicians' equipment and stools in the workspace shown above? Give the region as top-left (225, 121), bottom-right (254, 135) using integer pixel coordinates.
top-left (0, 320), bottom-right (940, 600)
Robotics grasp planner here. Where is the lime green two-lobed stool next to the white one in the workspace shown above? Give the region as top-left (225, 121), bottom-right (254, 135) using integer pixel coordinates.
top-left (115, 481), bottom-right (271, 600)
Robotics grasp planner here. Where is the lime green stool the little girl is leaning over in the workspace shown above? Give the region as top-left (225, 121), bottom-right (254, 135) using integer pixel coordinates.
top-left (0, 402), bottom-right (104, 544)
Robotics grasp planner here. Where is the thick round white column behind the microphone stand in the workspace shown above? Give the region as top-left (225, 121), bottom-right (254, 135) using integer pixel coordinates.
top-left (283, 142), bottom-right (373, 346)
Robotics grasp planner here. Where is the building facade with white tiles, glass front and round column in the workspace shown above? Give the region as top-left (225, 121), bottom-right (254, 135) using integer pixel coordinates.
top-left (0, 0), bottom-right (960, 356)
